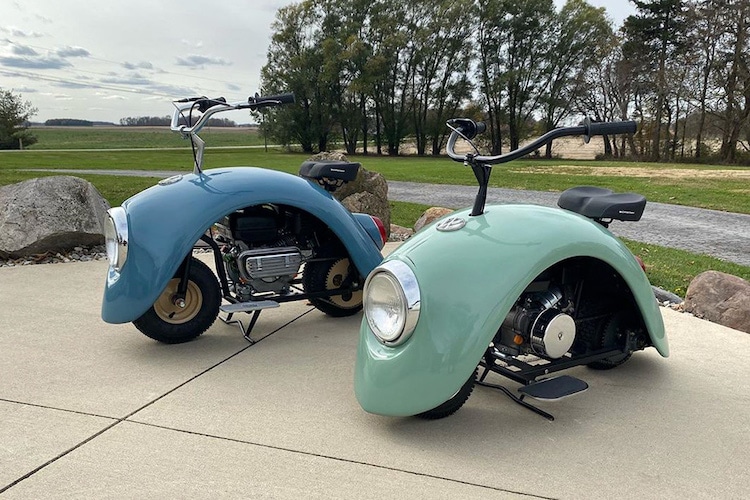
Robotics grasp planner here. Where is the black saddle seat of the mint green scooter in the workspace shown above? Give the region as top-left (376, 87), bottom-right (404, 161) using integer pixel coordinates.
top-left (557, 186), bottom-right (646, 221)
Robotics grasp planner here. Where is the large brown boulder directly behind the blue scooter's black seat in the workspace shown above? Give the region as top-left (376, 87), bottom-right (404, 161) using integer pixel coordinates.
top-left (309, 152), bottom-right (391, 234)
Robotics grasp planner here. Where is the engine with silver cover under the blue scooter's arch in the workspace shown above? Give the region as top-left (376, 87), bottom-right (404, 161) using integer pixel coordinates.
top-left (214, 205), bottom-right (314, 301)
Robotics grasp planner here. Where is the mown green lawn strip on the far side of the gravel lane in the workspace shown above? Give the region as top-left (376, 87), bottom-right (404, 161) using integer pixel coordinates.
top-left (0, 146), bottom-right (750, 214)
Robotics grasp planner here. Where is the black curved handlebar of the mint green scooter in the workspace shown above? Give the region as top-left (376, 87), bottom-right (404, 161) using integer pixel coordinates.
top-left (446, 118), bottom-right (637, 165)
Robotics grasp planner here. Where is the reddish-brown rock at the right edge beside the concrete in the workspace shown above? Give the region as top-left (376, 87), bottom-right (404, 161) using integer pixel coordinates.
top-left (685, 271), bottom-right (750, 333)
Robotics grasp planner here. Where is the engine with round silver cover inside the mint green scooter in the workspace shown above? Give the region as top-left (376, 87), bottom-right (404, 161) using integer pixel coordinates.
top-left (495, 287), bottom-right (576, 359)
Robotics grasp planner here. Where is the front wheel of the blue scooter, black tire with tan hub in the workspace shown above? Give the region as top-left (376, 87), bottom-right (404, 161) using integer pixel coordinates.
top-left (133, 257), bottom-right (221, 344)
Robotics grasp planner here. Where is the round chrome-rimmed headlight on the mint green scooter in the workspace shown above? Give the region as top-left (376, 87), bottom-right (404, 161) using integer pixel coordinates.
top-left (364, 260), bottom-right (421, 346)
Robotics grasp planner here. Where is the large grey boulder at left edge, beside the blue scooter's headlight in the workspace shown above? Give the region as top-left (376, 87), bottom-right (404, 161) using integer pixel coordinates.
top-left (0, 175), bottom-right (109, 259)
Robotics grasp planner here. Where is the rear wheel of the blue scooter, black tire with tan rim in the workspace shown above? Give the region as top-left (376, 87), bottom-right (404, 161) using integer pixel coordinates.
top-left (302, 257), bottom-right (362, 318)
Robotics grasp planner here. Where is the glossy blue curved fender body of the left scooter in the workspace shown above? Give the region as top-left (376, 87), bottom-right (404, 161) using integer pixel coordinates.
top-left (102, 167), bottom-right (382, 323)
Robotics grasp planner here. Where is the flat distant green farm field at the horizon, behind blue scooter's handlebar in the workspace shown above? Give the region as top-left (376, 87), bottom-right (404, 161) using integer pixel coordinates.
top-left (28, 127), bottom-right (263, 150)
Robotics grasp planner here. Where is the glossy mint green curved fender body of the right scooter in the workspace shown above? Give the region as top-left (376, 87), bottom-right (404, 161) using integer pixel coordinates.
top-left (354, 205), bottom-right (669, 416)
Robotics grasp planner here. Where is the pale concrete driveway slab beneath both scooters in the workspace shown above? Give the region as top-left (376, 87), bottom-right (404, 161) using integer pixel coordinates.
top-left (0, 252), bottom-right (750, 500)
